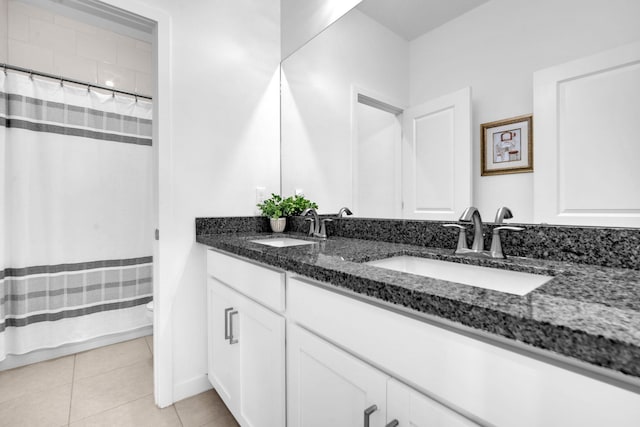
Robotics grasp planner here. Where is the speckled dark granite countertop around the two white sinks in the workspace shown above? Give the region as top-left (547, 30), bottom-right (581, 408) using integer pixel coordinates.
top-left (196, 233), bottom-right (640, 385)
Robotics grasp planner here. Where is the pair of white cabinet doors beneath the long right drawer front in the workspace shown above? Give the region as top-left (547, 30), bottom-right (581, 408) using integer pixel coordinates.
top-left (287, 325), bottom-right (477, 427)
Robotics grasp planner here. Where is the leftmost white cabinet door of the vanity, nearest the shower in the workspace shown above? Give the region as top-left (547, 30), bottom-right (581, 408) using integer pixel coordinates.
top-left (207, 277), bottom-right (240, 409)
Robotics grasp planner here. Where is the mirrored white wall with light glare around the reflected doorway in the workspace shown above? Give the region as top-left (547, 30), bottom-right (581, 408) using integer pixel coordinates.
top-left (282, 10), bottom-right (409, 214)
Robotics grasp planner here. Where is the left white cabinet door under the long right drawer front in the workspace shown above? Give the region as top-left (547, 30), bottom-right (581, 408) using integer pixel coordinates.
top-left (287, 325), bottom-right (388, 427)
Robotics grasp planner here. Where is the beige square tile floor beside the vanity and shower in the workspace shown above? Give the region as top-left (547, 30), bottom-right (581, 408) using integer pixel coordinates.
top-left (0, 336), bottom-right (238, 427)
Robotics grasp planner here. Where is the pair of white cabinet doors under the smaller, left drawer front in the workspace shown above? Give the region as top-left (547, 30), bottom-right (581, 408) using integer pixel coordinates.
top-left (207, 251), bottom-right (285, 427)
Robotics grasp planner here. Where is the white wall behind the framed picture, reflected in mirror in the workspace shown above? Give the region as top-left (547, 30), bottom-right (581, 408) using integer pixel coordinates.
top-left (410, 0), bottom-right (640, 222)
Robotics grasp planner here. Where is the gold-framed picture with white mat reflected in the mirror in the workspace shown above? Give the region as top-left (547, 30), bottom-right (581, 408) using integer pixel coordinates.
top-left (480, 114), bottom-right (533, 176)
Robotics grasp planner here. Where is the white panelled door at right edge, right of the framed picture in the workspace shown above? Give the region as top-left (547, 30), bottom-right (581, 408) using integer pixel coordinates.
top-left (533, 43), bottom-right (640, 227)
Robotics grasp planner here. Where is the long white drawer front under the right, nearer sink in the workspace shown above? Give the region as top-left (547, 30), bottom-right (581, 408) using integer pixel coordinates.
top-left (287, 277), bottom-right (640, 426)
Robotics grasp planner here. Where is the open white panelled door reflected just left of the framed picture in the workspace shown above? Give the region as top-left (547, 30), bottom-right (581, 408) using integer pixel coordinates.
top-left (402, 88), bottom-right (472, 221)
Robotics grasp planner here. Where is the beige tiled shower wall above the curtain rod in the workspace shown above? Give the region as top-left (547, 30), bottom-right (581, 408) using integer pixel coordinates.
top-left (0, 0), bottom-right (153, 95)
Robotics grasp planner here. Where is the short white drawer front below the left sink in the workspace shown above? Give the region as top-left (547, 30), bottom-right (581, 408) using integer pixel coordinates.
top-left (207, 249), bottom-right (285, 312)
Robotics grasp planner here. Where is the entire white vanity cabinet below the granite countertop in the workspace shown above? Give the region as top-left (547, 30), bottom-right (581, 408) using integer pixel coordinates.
top-left (207, 251), bottom-right (640, 427)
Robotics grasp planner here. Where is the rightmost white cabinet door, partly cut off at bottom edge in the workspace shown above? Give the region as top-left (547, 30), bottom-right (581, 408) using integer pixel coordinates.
top-left (387, 379), bottom-right (477, 427)
